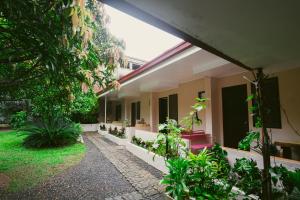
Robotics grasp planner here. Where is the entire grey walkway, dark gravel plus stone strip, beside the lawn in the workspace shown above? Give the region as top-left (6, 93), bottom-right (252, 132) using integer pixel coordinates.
top-left (0, 134), bottom-right (164, 200)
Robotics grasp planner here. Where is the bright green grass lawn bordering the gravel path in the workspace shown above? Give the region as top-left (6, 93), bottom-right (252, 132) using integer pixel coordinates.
top-left (0, 131), bottom-right (85, 192)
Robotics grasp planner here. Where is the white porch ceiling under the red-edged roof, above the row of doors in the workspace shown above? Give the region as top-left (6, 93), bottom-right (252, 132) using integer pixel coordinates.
top-left (102, 47), bottom-right (245, 99)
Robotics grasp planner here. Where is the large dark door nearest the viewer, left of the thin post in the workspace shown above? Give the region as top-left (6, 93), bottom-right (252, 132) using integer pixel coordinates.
top-left (222, 84), bottom-right (249, 148)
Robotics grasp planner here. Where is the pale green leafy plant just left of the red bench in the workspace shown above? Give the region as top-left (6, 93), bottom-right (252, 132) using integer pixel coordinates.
top-left (151, 119), bottom-right (186, 159)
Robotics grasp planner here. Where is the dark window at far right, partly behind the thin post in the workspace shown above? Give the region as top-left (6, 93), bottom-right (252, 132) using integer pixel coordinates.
top-left (251, 77), bottom-right (282, 128)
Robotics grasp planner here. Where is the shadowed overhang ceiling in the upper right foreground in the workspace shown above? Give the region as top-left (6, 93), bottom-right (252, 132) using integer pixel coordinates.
top-left (101, 0), bottom-right (300, 68)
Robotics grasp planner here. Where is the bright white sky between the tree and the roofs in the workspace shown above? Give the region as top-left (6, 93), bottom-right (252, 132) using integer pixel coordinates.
top-left (105, 5), bottom-right (182, 61)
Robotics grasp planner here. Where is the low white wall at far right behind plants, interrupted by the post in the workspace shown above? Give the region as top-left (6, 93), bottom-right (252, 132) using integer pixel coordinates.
top-left (223, 147), bottom-right (300, 170)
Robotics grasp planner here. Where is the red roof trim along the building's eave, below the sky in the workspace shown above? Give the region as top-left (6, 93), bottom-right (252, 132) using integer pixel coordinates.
top-left (118, 41), bottom-right (193, 83)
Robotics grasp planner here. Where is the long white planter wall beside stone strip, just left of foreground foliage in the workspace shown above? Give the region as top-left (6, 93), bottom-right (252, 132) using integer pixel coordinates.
top-left (126, 142), bottom-right (168, 173)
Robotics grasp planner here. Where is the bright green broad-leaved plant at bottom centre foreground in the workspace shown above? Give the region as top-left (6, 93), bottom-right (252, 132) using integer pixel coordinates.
top-left (161, 149), bottom-right (232, 199)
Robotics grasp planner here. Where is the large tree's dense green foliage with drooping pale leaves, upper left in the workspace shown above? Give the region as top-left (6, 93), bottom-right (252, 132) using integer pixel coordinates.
top-left (0, 0), bottom-right (122, 118)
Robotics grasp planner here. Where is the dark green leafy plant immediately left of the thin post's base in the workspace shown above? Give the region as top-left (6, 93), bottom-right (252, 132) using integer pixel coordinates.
top-left (232, 158), bottom-right (262, 197)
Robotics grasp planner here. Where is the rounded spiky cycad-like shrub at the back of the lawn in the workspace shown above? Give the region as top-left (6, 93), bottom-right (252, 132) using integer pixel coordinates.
top-left (22, 117), bottom-right (82, 148)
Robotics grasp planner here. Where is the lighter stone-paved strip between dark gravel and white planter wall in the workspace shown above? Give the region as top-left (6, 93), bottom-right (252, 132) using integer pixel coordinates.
top-left (87, 134), bottom-right (165, 199)
